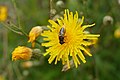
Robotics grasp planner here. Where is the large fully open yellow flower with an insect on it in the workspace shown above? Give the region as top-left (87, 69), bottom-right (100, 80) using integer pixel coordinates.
top-left (41, 10), bottom-right (100, 68)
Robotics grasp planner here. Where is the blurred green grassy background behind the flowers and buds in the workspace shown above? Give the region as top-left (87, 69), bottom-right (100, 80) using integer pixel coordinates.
top-left (0, 0), bottom-right (120, 80)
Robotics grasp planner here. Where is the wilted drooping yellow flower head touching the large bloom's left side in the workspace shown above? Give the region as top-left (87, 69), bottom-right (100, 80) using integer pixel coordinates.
top-left (28, 26), bottom-right (43, 47)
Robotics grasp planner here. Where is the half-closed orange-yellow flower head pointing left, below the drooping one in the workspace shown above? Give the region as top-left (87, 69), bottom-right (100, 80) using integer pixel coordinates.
top-left (12, 46), bottom-right (32, 61)
